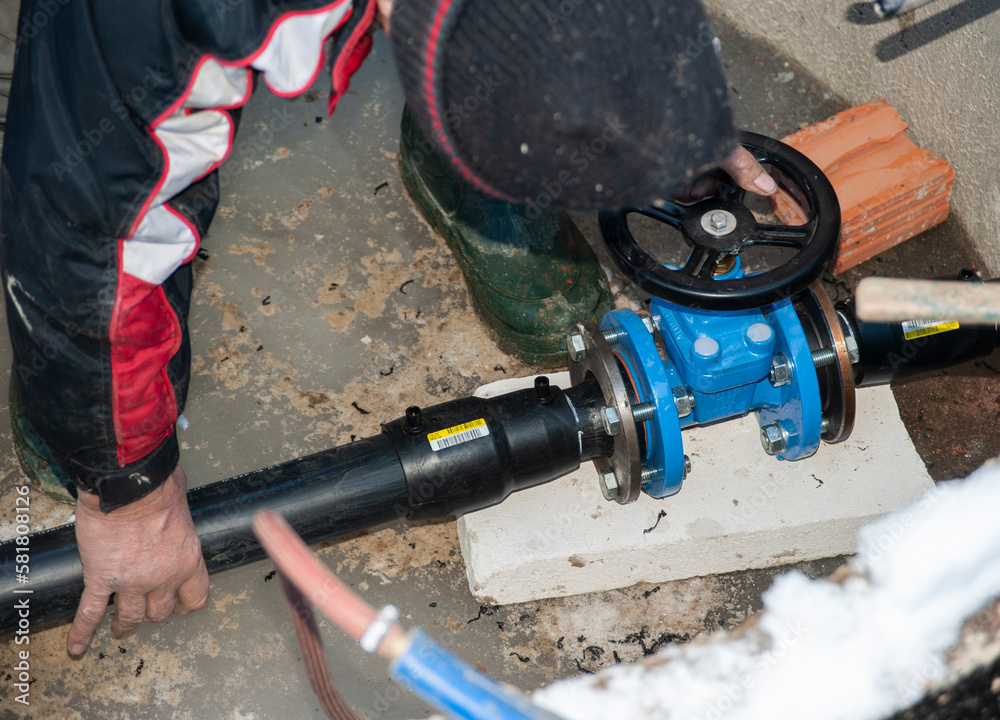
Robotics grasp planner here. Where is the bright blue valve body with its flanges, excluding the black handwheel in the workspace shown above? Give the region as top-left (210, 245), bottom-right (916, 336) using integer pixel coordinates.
top-left (601, 290), bottom-right (822, 498)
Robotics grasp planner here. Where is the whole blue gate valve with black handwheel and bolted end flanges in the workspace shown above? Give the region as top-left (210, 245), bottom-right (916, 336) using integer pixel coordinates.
top-left (568, 133), bottom-right (858, 503)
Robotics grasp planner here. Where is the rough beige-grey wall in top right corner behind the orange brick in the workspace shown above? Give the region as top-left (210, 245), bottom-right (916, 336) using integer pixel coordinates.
top-left (704, 0), bottom-right (1000, 277)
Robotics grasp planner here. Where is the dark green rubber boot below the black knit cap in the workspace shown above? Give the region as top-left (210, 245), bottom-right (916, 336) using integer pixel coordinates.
top-left (399, 109), bottom-right (611, 367)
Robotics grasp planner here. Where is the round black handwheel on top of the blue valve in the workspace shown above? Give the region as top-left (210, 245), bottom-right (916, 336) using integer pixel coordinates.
top-left (599, 132), bottom-right (840, 310)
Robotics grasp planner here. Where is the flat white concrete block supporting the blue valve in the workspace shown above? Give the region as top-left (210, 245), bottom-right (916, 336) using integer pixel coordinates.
top-left (458, 373), bottom-right (933, 604)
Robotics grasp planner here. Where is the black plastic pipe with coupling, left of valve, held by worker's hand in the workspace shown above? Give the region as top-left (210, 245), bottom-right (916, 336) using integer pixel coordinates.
top-left (0, 377), bottom-right (612, 636)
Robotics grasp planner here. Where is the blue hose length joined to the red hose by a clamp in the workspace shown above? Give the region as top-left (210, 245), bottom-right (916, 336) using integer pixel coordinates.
top-left (389, 628), bottom-right (561, 720)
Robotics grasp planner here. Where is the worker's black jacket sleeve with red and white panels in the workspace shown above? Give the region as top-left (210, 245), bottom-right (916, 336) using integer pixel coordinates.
top-left (0, 0), bottom-right (375, 512)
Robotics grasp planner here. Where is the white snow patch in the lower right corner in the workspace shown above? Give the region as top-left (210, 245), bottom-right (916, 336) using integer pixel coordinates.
top-left (534, 466), bottom-right (1000, 720)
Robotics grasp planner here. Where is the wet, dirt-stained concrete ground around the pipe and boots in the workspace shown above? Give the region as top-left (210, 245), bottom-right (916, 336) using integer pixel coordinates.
top-left (0, 15), bottom-right (1000, 720)
